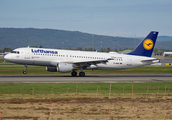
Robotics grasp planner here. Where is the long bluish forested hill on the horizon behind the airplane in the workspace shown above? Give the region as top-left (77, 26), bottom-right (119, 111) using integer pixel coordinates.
top-left (0, 28), bottom-right (172, 50)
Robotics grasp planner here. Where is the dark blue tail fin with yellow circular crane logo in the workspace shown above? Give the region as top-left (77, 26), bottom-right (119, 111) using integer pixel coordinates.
top-left (128, 31), bottom-right (158, 57)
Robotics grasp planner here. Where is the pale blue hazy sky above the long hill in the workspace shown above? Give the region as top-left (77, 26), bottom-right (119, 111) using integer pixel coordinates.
top-left (0, 0), bottom-right (172, 37)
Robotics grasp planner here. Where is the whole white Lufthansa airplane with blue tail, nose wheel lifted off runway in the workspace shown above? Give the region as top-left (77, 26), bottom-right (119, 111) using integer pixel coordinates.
top-left (4, 31), bottom-right (159, 77)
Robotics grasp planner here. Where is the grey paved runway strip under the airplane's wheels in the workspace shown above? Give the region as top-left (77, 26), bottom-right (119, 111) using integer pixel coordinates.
top-left (0, 74), bottom-right (172, 83)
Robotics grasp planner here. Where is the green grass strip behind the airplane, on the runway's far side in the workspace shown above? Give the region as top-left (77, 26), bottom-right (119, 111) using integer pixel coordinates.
top-left (0, 66), bottom-right (172, 75)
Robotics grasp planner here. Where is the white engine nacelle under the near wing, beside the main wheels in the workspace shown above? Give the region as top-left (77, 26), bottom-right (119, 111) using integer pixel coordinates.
top-left (57, 63), bottom-right (73, 73)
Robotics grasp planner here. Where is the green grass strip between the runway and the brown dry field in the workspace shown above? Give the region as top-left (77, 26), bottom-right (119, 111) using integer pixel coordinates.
top-left (0, 82), bottom-right (172, 94)
